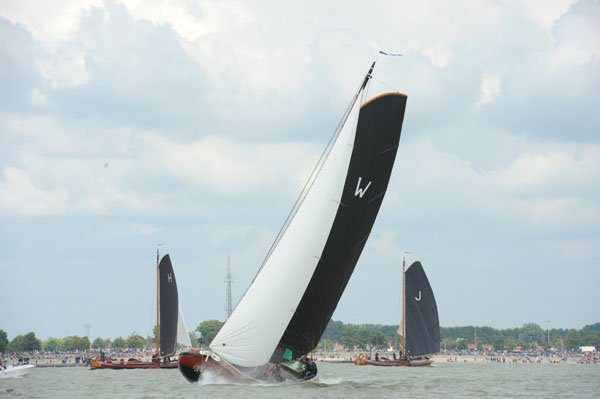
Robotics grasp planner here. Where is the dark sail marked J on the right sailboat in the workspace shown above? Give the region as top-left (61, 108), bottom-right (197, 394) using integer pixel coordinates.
top-left (404, 262), bottom-right (440, 356)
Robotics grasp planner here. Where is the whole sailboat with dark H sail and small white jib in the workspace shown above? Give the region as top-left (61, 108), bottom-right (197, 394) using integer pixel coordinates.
top-left (90, 250), bottom-right (192, 370)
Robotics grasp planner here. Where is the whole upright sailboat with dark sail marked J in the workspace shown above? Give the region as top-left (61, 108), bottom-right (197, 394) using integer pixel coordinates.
top-left (354, 259), bottom-right (440, 367)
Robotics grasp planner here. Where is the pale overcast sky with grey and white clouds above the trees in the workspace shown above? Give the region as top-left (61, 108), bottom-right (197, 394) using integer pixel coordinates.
top-left (0, 0), bottom-right (600, 338)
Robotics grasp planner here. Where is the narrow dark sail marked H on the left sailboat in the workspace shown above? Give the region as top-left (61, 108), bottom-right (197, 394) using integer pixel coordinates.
top-left (158, 255), bottom-right (179, 356)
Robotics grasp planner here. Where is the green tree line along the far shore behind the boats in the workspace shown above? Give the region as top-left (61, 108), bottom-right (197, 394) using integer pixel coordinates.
top-left (0, 320), bottom-right (600, 353)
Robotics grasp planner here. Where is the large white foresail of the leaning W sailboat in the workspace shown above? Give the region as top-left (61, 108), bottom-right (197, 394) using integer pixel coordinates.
top-left (210, 95), bottom-right (360, 367)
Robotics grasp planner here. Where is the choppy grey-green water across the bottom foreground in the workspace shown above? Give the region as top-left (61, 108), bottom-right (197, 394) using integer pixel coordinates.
top-left (0, 363), bottom-right (600, 399)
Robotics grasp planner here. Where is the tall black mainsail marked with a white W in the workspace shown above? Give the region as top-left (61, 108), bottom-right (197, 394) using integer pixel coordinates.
top-left (271, 88), bottom-right (407, 362)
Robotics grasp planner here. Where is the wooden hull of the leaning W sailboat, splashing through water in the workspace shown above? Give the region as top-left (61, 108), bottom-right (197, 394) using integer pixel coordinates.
top-left (179, 349), bottom-right (316, 384)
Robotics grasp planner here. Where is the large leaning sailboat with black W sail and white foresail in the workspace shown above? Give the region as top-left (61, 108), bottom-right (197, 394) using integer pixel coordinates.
top-left (179, 62), bottom-right (407, 383)
